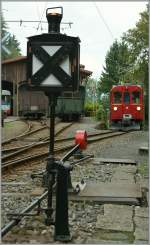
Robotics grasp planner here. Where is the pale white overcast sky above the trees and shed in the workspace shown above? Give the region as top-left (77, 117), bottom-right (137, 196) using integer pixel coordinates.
top-left (2, 1), bottom-right (147, 79)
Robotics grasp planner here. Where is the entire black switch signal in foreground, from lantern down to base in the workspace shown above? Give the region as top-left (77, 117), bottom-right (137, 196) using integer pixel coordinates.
top-left (27, 7), bottom-right (80, 241)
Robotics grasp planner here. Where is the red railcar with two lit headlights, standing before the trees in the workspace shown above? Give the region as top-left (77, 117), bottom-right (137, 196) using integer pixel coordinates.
top-left (110, 85), bottom-right (144, 128)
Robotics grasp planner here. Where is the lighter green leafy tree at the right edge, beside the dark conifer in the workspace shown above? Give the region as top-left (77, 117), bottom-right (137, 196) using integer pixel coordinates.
top-left (122, 5), bottom-right (149, 120)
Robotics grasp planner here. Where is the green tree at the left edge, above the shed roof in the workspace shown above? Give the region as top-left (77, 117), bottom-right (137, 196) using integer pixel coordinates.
top-left (1, 15), bottom-right (21, 60)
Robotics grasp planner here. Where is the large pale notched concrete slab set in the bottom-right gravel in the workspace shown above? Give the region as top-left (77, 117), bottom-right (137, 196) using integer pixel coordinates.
top-left (96, 204), bottom-right (134, 232)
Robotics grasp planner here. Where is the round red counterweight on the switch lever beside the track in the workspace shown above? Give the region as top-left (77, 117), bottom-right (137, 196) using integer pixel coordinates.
top-left (75, 130), bottom-right (87, 150)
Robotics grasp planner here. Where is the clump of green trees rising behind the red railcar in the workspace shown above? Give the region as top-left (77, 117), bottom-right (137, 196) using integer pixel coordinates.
top-left (99, 5), bottom-right (149, 120)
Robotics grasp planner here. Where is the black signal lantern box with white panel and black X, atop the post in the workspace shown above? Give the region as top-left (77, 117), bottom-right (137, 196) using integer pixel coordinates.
top-left (27, 7), bottom-right (80, 93)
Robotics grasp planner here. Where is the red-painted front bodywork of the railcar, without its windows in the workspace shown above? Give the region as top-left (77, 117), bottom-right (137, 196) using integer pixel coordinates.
top-left (110, 85), bottom-right (144, 121)
